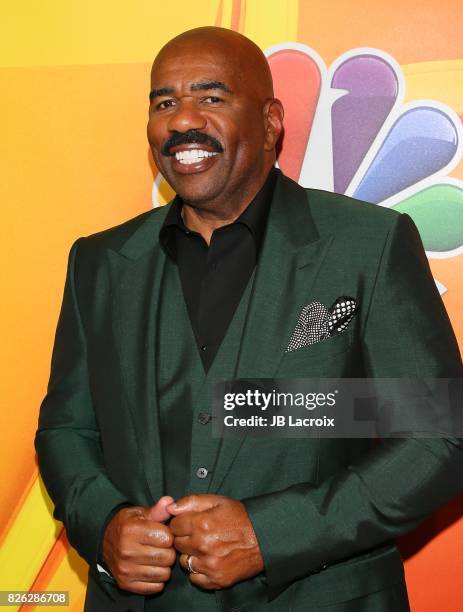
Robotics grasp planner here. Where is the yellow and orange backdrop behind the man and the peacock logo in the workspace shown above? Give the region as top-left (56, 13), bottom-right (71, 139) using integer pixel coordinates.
top-left (0, 0), bottom-right (463, 612)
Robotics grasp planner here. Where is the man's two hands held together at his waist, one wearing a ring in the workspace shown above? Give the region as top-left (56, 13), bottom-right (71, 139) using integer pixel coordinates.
top-left (103, 494), bottom-right (263, 595)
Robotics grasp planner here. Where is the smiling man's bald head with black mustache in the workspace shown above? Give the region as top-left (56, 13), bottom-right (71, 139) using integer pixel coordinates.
top-left (148, 27), bottom-right (283, 219)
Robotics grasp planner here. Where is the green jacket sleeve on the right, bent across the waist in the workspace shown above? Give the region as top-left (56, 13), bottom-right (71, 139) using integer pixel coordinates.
top-left (243, 214), bottom-right (463, 599)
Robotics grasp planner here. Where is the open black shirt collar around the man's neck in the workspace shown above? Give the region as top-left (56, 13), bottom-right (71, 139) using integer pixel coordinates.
top-left (159, 167), bottom-right (279, 260)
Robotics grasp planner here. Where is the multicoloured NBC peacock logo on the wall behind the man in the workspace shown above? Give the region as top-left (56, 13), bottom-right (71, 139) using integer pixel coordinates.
top-left (153, 43), bottom-right (463, 294)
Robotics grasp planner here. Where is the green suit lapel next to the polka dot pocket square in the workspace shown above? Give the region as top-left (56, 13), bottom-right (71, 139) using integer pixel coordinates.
top-left (209, 174), bottom-right (332, 491)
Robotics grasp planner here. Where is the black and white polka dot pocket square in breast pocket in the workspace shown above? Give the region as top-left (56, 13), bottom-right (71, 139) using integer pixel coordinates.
top-left (286, 295), bottom-right (358, 353)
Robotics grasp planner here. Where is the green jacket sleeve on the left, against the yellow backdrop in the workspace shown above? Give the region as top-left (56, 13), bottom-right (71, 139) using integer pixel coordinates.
top-left (35, 238), bottom-right (130, 567)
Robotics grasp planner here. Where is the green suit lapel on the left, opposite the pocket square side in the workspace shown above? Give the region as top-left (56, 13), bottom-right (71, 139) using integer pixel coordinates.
top-left (108, 207), bottom-right (167, 501)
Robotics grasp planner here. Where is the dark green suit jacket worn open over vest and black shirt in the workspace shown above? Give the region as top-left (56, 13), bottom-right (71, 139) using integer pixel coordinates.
top-left (35, 174), bottom-right (463, 612)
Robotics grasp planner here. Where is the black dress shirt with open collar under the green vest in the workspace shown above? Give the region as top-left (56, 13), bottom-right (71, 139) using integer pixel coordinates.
top-left (159, 168), bottom-right (278, 372)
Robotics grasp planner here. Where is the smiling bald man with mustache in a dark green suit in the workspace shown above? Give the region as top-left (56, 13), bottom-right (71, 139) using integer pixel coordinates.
top-left (36, 27), bottom-right (463, 612)
